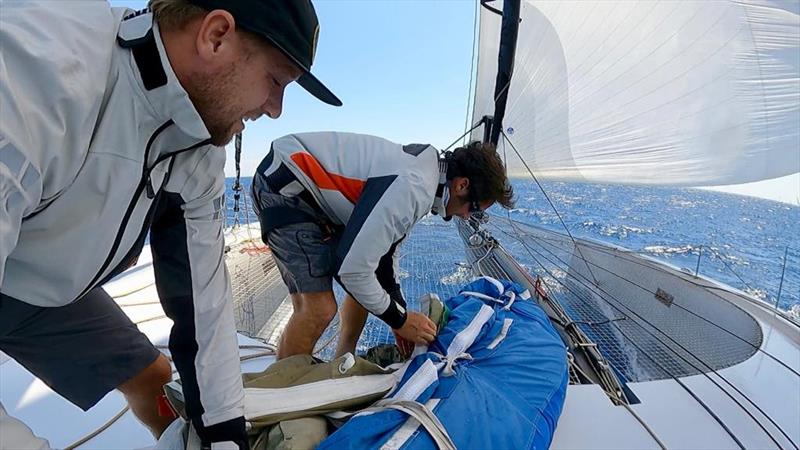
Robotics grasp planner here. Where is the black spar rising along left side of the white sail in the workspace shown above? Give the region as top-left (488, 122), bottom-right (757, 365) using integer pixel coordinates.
top-left (481, 0), bottom-right (520, 146)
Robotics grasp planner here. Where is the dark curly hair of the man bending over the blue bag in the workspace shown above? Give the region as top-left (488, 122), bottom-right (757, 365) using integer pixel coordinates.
top-left (447, 141), bottom-right (514, 209)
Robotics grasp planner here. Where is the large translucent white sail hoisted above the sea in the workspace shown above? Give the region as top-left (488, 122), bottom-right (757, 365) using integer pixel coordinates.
top-left (472, 0), bottom-right (800, 186)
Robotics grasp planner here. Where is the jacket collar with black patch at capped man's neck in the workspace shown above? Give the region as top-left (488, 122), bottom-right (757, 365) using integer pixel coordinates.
top-left (117, 10), bottom-right (210, 140)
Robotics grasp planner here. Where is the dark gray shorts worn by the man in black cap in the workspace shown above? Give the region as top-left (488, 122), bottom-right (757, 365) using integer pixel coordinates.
top-left (0, 288), bottom-right (160, 410)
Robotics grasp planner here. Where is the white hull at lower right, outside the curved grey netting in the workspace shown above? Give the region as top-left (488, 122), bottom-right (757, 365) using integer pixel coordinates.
top-left (552, 251), bottom-right (800, 449)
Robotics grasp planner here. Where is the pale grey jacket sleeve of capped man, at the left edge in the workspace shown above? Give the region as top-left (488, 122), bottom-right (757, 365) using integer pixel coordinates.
top-left (0, 1), bottom-right (116, 285)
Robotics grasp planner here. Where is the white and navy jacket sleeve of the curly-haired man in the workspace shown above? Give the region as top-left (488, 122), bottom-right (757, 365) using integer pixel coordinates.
top-left (335, 175), bottom-right (425, 329)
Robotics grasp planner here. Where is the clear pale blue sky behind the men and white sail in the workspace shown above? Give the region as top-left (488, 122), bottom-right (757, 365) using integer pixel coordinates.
top-left (111, 0), bottom-right (800, 205)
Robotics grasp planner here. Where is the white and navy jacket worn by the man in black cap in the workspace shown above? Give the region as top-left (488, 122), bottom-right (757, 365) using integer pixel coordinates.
top-left (0, 1), bottom-right (244, 441)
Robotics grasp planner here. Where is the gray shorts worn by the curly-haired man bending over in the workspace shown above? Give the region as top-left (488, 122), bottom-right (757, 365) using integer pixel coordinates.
top-left (253, 179), bottom-right (340, 294)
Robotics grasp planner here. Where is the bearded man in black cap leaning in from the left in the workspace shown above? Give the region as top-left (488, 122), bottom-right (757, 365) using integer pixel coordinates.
top-left (0, 0), bottom-right (341, 448)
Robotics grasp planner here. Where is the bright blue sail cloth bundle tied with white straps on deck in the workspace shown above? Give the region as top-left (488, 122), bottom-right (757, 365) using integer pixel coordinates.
top-left (318, 277), bottom-right (568, 450)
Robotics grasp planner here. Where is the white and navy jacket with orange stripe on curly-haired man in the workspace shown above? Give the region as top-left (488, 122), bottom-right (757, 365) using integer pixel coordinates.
top-left (253, 132), bottom-right (439, 328)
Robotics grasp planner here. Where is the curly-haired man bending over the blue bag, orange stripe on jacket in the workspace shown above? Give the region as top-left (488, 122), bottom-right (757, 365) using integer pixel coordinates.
top-left (252, 133), bottom-right (512, 358)
